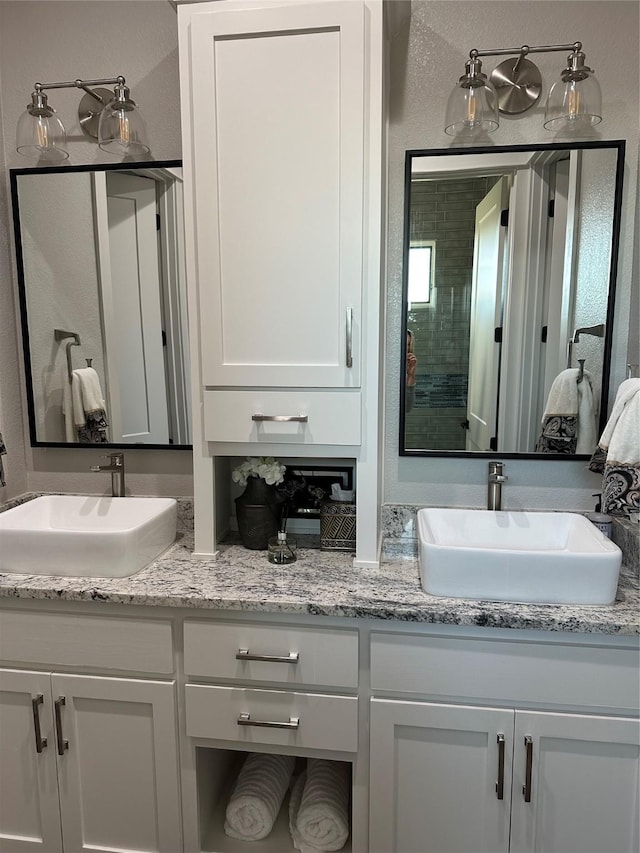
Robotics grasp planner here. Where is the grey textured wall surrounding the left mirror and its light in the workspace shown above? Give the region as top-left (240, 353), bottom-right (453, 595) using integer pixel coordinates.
top-left (0, 0), bottom-right (193, 500)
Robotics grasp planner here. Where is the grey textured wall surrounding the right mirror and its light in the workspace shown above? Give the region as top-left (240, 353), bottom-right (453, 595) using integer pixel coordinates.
top-left (384, 0), bottom-right (640, 509)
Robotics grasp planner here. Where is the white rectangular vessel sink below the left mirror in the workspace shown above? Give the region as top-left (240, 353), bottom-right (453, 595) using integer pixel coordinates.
top-left (0, 495), bottom-right (177, 578)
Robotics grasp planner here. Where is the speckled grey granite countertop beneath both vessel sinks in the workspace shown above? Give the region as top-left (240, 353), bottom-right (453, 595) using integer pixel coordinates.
top-left (0, 532), bottom-right (640, 635)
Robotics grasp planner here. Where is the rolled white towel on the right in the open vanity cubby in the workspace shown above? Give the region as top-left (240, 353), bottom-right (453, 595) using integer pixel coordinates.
top-left (289, 758), bottom-right (351, 853)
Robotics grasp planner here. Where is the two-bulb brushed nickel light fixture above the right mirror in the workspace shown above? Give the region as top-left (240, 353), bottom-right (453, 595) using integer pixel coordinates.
top-left (444, 41), bottom-right (602, 137)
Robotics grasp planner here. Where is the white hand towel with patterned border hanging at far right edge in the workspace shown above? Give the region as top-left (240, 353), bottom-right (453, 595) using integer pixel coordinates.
top-left (589, 379), bottom-right (640, 518)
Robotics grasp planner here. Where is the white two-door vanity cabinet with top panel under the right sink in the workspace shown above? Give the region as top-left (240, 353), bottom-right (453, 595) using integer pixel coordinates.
top-left (369, 632), bottom-right (640, 853)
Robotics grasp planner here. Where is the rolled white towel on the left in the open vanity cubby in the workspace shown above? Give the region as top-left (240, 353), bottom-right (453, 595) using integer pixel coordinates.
top-left (224, 752), bottom-right (295, 841)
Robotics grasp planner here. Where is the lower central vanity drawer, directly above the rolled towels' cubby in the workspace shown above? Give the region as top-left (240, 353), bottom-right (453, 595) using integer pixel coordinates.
top-left (185, 684), bottom-right (358, 752)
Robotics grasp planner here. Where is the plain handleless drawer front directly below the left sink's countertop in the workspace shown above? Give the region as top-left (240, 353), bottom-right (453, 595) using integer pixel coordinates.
top-left (0, 610), bottom-right (174, 673)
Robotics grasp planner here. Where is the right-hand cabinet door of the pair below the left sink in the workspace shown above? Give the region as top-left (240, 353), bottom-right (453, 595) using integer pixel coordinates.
top-left (51, 674), bottom-right (182, 853)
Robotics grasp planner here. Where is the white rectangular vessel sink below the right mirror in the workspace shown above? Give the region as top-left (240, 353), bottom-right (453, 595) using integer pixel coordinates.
top-left (417, 508), bottom-right (622, 604)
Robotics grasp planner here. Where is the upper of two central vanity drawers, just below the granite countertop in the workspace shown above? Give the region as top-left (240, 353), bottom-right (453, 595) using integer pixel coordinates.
top-left (184, 620), bottom-right (358, 689)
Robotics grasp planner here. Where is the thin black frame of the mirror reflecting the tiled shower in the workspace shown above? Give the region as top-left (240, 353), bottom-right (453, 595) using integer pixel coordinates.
top-left (398, 139), bottom-right (625, 462)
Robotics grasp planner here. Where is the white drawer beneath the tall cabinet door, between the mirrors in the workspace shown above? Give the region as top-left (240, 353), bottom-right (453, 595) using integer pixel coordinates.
top-left (204, 390), bottom-right (361, 446)
